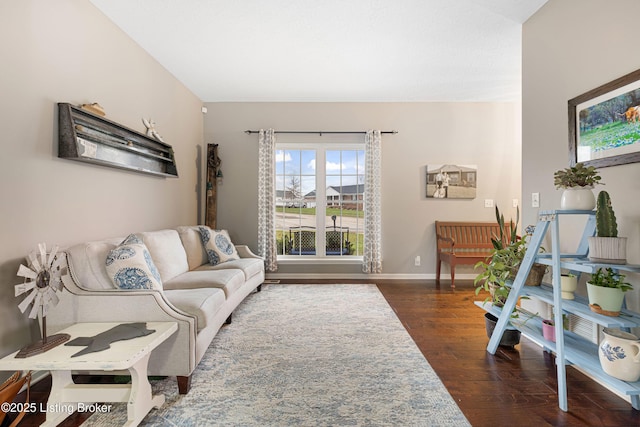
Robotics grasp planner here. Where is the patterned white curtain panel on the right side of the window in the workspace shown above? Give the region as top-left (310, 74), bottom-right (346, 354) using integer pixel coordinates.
top-left (362, 130), bottom-right (382, 273)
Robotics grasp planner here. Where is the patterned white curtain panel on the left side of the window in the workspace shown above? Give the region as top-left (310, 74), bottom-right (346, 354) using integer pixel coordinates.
top-left (258, 129), bottom-right (278, 271)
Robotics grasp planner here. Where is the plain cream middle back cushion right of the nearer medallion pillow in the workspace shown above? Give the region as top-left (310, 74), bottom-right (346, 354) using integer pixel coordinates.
top-left (138, 230), bottom-right (189, 282)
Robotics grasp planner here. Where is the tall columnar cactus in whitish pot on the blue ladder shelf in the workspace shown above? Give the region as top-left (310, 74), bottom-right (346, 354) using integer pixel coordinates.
top-left (589, 191), bottom-right (627, 264)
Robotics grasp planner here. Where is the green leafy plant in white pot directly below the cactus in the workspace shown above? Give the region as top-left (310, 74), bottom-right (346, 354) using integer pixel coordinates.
top-left (587, 267), bottom-right (633, 316)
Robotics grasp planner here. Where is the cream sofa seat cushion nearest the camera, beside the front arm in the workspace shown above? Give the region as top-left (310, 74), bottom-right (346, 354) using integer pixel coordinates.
top-left (164, 288), bottom-right (226, 332)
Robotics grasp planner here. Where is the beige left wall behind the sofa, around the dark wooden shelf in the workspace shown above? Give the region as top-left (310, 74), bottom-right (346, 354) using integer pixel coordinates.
top-left (0, 0), bottom-right (203, 355)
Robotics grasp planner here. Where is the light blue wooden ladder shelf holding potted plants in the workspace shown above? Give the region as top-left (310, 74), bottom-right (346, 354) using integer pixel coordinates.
top-left (476, 210), bottom-right (640, 411)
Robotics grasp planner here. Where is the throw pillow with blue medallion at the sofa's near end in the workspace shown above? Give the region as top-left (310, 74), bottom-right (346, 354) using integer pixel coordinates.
top-left (106, 234), bottom-right (162, 289)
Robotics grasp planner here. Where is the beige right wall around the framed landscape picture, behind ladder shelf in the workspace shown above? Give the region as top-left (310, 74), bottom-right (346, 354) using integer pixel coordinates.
top-left (522, 0), bottom-right (640, 310)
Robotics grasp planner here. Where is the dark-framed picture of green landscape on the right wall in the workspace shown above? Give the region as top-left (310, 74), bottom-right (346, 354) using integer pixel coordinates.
top-left (568, 70), bottom-right (640, 168)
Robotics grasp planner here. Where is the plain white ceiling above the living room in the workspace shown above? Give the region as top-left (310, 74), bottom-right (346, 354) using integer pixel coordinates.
top-left (91, 0), bottom-right (547, 102)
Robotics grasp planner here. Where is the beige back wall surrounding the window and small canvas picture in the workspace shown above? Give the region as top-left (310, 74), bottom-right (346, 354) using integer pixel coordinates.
top-left (205, 103), bottom-right (521, 278)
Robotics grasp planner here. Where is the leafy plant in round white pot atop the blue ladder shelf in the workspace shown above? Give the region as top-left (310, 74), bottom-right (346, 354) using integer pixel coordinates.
top-left (553, 163), bottom-right (602, 211)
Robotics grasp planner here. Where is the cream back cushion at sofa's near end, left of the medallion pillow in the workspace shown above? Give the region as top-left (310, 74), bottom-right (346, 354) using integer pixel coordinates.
top-left (65, 237), bottom-right (122, 290)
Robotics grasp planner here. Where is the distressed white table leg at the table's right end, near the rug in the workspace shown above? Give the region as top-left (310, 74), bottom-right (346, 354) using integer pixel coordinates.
top-left (125, 353), bottom-right (164, 426)
